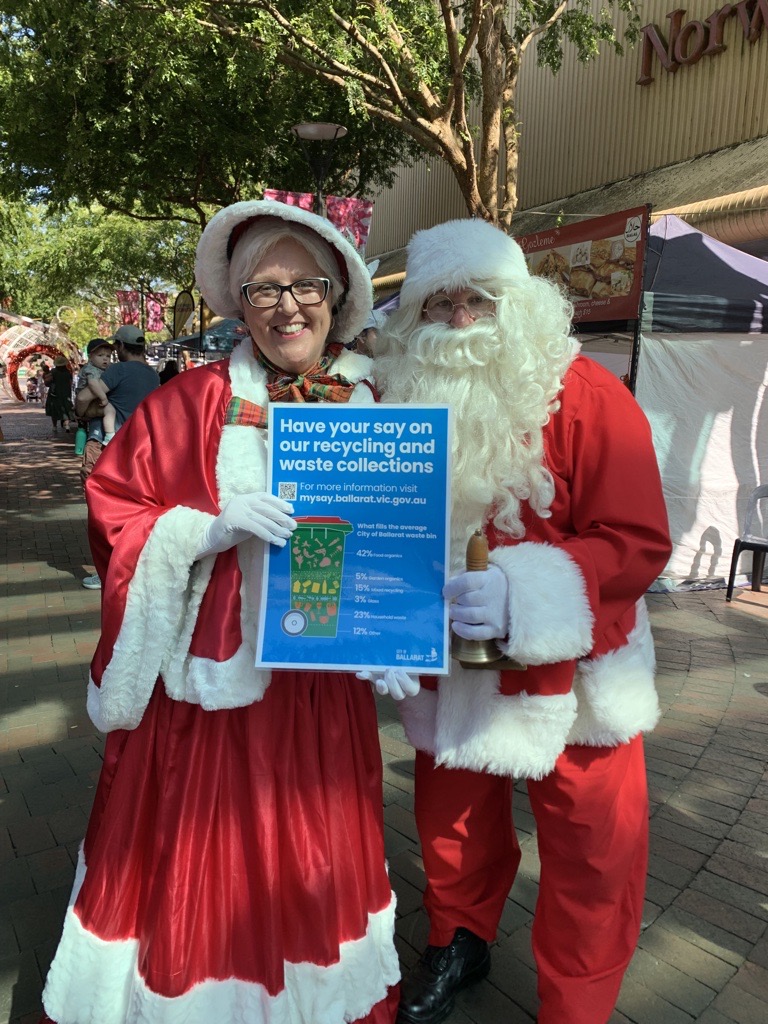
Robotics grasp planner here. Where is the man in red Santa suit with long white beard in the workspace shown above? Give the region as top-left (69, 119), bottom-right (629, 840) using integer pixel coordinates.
top-left (376, 220), bottom-right (671, 1024)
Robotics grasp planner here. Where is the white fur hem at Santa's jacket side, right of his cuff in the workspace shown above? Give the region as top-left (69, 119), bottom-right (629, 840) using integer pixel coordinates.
top-left (568, 598), bottom-right (660, 746)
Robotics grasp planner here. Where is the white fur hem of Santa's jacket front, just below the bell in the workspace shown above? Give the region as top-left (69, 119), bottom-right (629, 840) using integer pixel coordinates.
top-left (400, 665), bottom-right (577, 778)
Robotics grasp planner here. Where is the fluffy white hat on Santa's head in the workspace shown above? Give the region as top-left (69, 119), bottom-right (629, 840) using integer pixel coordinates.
top-left (400, 219), bottom-right (529, 306)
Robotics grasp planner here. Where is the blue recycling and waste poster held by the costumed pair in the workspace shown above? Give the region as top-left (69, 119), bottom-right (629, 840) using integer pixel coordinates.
top-left (256, 402), bottom-right (451, 675)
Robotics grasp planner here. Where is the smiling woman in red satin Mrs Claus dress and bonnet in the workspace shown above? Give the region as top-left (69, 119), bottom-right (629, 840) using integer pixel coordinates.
top-left (37, 202), bottom-right (399, 1024)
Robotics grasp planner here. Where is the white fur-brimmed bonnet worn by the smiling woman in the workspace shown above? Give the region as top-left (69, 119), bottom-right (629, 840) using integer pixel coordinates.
top-left (195, 200), bottom-right (373, 342)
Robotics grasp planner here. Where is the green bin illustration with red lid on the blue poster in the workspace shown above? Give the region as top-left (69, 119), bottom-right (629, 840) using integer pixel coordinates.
top-left (281, 516), bottom-right (354, 637)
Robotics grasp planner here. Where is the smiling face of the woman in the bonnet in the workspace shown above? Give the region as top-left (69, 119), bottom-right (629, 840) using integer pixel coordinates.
top-left (243, 239), bottom-right (333, 374)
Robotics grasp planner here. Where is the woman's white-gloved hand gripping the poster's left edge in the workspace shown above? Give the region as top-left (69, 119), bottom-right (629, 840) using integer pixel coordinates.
top-left (197, 490), bottom-right (296, 558)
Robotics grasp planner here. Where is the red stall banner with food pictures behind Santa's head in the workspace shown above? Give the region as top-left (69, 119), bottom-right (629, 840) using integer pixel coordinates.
top-left (515, 206), bottom-right (650, 324)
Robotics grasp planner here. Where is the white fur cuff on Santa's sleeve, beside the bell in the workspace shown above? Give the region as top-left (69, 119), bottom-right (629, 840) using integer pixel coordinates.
top-left (488, 542), bottom-right (595, 665)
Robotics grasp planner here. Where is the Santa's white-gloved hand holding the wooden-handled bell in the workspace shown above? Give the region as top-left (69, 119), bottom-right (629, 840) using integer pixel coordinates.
top-left (442, 565), bottom-right (509, 640)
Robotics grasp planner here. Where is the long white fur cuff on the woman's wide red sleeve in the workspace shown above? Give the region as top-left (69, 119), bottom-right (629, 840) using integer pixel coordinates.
top-left (88, 505), bottom-right (213, 732)
